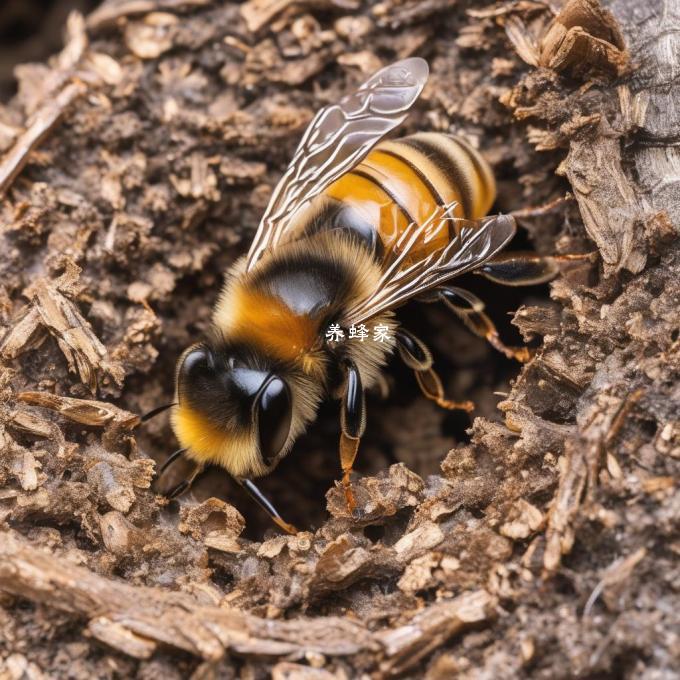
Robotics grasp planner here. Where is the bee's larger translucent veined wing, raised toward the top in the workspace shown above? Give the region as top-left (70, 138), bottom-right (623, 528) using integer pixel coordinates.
top-left (247, 57), bottom-right (429, 269)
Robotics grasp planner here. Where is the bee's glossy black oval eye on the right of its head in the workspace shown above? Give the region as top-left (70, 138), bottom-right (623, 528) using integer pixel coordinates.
top-left (255, 377), bottom-right (293, 465)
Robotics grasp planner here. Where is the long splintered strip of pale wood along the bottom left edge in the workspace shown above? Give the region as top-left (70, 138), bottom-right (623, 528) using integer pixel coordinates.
top-left (0, 532), bottom-right (493, 674)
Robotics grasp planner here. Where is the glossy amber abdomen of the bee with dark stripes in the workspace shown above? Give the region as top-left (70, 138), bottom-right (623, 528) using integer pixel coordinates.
top-left (324, 132), bottom-right (496, 256)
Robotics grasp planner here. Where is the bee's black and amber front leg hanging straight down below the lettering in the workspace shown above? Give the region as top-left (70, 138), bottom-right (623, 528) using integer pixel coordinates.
top-left (340, 359), bottom-right (366, 512)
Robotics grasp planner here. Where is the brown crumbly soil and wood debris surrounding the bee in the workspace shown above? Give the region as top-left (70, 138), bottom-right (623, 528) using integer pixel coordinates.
top-left (0, 0), bottom-right (680, 679)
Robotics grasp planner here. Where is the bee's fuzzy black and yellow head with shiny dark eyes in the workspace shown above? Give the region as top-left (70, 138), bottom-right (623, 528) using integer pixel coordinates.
top-left (172, 343), bottom-right (295, 477)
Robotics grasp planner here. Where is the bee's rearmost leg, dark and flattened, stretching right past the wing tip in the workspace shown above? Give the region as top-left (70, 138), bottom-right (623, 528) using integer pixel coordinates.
top-left (475, 252), bottom-right (595, 286)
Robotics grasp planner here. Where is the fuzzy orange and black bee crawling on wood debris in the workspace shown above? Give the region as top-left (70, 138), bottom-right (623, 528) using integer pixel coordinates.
top-left (149, 58), bottom-right (556, 532)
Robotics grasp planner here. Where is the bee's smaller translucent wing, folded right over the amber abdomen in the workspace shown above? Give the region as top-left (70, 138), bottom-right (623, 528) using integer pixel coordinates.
top-left (347, 203), bottom-right (516, 325)
